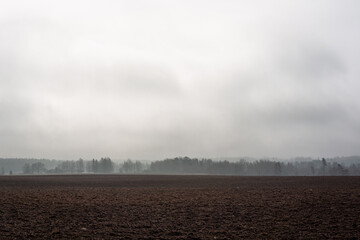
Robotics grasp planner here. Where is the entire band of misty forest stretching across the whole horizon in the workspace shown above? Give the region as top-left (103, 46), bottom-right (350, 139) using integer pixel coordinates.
top-left (0, 156), bottom-right (360, 176)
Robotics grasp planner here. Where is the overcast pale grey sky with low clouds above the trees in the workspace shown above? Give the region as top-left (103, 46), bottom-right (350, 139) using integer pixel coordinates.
top-left (0, 0), bottom-right (360, 160)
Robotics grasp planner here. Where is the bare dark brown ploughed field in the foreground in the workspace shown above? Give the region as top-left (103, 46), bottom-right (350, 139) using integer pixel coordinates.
top-left (0, 175), bottom-right (360, 239)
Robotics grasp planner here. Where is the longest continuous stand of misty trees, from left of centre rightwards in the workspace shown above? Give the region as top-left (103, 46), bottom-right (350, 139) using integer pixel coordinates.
top-left (146, 157), bottom-right (354, 176)
